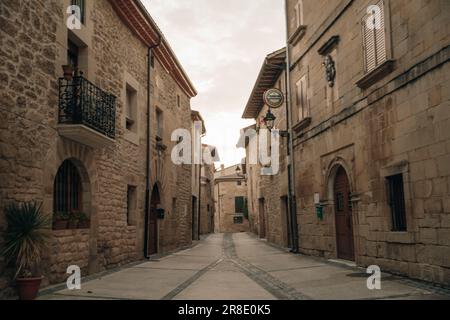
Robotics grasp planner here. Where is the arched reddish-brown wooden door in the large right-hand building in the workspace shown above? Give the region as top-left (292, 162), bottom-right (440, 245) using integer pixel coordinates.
top-left (333, 166), bottom-right (355, 261)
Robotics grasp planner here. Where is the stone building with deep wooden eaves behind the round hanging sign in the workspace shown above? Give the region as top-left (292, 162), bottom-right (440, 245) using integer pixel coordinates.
top-left (243, 48), bottom-right (290, 247)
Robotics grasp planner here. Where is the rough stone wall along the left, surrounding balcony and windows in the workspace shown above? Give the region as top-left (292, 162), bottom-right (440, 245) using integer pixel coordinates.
top-left (0, 0), bottom-right (195, 294)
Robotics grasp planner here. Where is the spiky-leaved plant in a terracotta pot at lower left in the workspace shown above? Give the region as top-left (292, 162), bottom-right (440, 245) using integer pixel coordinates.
top-left (3, 202), bottom-right (50, 300)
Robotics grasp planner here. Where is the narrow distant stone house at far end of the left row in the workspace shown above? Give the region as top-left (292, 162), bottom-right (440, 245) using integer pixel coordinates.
top-left (200, 144), bottom-right (218, 235)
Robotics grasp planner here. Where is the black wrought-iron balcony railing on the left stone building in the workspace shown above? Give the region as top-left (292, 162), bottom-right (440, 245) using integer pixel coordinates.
top-left (59, 76), bottom-right (116, 139)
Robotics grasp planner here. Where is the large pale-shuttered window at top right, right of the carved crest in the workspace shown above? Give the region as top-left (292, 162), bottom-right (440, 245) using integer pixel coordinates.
top-left (361, 0), bottom-right (387, 73)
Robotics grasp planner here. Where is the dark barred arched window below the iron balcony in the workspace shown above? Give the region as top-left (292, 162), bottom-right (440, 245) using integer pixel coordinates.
top-left (53, 160), bottom-right (83, 215)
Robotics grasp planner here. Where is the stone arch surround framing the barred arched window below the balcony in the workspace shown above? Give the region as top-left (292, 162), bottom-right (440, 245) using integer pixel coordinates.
top-left (43, 138), bottom-right (99, 274)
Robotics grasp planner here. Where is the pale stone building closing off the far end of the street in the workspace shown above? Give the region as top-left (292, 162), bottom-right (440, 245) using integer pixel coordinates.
top-left (214, 165), bottom-right (249, 233)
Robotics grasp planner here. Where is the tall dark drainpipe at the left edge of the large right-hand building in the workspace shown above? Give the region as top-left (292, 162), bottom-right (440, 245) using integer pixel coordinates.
top-left (284, 0), bottom-right (299, 253)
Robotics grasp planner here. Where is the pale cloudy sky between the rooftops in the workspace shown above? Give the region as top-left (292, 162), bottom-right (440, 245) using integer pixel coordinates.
top-left (142, 0), bottom-right (285, 166)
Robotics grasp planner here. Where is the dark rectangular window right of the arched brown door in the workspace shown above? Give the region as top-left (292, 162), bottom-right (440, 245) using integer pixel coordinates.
top-left (386, 174), bottom-right (406, 231)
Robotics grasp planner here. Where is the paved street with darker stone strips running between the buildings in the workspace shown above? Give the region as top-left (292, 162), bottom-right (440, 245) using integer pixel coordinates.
top-left (40, 233), bottom-right (450, 300)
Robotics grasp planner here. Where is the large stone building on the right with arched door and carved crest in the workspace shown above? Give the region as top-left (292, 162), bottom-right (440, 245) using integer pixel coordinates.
top-left (287, 0), bottom-right (450, 284)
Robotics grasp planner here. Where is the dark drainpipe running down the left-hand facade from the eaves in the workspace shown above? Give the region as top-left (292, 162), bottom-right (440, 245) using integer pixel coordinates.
top-left (144, 35), bottom-right (162, 259)
